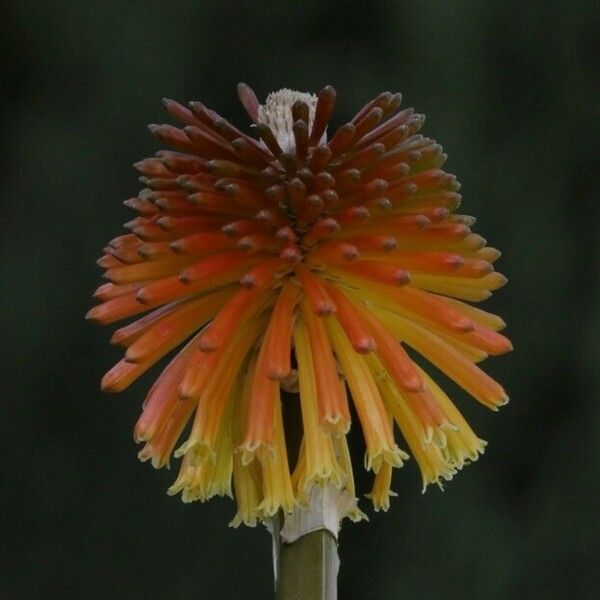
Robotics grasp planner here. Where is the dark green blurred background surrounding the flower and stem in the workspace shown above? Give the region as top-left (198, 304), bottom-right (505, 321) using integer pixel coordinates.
top-left (0, 0), bottom-right (600, 600)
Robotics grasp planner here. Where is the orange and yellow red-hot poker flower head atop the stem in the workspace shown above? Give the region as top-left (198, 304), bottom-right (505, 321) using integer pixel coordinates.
top-left (89, 84), bottom-right (511, 524)
